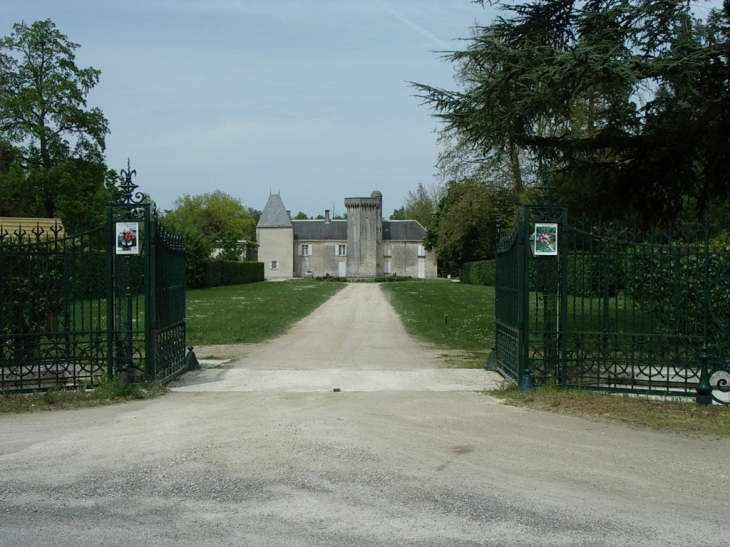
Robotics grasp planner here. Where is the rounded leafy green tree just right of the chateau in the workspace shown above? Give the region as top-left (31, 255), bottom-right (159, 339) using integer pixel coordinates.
top-left (424, 179), bottom-right (515, 265)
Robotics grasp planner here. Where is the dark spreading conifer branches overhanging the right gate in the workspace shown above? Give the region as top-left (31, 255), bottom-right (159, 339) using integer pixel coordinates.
top-left (414, 0), bottom-right (730, 226)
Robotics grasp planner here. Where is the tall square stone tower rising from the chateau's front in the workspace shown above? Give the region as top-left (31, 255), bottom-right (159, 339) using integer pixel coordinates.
top-left (345, 190), bottom-right (383, 277)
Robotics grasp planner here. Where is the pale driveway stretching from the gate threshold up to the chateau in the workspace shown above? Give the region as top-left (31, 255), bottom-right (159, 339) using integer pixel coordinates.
top-left (172, 283), bottom-right (501, 392)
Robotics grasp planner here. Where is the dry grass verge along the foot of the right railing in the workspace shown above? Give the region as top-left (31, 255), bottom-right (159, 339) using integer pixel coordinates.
top-left (489, 385), bottom-right (730, 438)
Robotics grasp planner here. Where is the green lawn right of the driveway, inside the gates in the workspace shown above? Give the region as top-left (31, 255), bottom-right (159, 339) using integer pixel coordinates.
top-left (382, 279), bottom-right (494, 368)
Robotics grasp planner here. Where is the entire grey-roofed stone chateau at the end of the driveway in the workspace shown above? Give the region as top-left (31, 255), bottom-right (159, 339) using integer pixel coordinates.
top-left (256, 191), bottom-right (436, 279)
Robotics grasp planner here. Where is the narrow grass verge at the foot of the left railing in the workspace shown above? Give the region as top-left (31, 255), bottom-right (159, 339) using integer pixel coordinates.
top-left (0, 380), bottom-right (167, 414)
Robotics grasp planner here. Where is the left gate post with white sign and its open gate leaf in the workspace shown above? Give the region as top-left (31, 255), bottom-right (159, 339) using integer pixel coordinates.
top-left (107, 170), bottom-right (185, 381)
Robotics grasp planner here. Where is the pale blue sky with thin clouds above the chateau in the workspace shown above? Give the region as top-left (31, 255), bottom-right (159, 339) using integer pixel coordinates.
top-left (0, 0), bottom-right (495, 217)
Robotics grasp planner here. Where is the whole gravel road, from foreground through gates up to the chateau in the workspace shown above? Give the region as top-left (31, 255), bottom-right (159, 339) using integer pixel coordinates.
top-left (0, 284), bottom-right (730, 547)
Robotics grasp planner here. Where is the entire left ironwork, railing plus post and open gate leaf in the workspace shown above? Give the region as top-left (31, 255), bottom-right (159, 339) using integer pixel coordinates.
top-left (0, 171), bottom-right (185, 392)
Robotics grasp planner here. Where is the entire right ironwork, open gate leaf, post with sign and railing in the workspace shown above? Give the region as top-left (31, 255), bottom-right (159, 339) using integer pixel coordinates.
top-left (493, 190), bottom-right (730, 404)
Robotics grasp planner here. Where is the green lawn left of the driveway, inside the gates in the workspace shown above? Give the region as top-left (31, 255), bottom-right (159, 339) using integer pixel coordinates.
top-left (186, 279), bottom-right (345, 346)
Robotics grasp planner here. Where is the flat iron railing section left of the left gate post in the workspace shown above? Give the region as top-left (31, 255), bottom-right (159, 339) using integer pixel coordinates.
top-left (0, 223), bottom-right (107, 391)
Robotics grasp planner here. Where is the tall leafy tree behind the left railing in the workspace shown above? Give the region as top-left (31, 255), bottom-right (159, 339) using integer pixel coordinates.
top-left (0, 20), bottom-right (117, 224)
